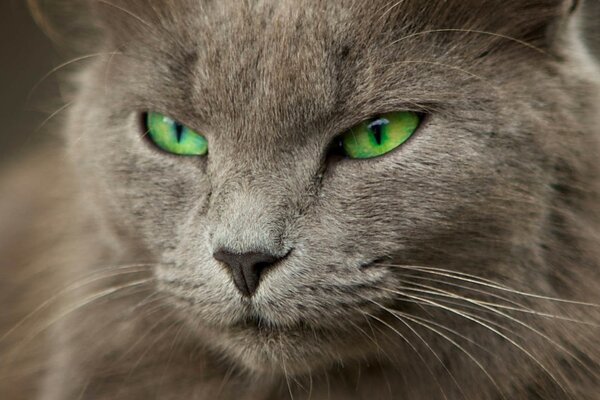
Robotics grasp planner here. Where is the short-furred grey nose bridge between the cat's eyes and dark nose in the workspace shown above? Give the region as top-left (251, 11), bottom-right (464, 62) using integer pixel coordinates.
top-left (207, 135), bottom-right (319, 257)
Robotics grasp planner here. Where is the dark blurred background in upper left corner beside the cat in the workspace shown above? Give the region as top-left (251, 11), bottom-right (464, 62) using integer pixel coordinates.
top-left (0, 0), bottom-right (58, 168)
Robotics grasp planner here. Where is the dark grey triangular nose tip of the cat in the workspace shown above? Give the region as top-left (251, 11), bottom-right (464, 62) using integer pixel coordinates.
top-left (213, 250), bottom-right (281, 297)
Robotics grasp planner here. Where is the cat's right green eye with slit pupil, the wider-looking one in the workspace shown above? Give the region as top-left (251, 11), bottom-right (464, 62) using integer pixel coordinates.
top-left (340, 111), bottom-right (421, 158)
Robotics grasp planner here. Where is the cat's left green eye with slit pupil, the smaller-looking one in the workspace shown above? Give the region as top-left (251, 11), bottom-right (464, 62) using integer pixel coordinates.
top-left (146, 112), bottom-right (208, 156)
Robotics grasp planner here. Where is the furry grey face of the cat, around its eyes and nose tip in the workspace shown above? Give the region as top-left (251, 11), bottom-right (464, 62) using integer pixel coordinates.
top-left (65, 0), bottom-right (592, 371)
